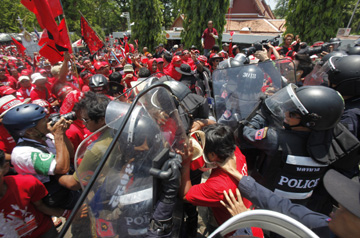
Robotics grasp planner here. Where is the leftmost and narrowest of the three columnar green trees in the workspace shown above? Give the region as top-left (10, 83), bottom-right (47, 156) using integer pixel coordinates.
top-left (130, 0), bottom-right (164, 49)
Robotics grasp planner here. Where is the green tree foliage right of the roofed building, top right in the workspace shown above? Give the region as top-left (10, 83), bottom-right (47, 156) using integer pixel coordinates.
top-left (285, 0), bottom-right (348, 43)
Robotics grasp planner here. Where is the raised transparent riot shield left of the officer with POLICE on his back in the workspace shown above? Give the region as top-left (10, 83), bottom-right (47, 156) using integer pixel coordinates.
top-left (212, 59), bottom-right (295, 129)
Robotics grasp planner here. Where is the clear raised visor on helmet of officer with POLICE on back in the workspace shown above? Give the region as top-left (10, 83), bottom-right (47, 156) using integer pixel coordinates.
top-left (265, 84), bottom-right (308, 119)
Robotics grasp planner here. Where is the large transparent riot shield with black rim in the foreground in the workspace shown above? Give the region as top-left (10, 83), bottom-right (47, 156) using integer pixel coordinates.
top-left (60, 85), bottom-right (187, 237)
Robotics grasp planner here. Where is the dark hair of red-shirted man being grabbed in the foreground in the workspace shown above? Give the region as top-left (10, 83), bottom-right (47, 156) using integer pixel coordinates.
top-left (204, 124), bottom-right (235, 161)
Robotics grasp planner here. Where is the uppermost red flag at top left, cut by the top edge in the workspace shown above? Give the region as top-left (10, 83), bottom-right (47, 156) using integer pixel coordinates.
top-left (21, 0), bottom-right (63, 44)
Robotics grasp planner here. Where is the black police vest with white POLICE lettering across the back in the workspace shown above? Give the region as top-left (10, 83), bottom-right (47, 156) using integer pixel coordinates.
top-left (263, 129), bottom-right (327, 200)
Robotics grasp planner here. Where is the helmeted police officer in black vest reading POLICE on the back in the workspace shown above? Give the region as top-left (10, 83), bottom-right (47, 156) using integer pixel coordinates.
top-left (243, 84), bottom-right (359, 204)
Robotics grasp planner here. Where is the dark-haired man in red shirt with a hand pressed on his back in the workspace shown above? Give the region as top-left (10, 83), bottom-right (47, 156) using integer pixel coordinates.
top-left (180, 124), bottom-right (262, 236)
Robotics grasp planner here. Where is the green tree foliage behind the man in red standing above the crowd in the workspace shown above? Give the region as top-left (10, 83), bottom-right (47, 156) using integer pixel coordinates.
top-left (179, 0), bottom-right (230, 49)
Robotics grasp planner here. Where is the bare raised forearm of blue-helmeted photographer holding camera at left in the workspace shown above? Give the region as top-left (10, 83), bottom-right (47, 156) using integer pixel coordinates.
top-left (47, 118), bottom-right (71, 174)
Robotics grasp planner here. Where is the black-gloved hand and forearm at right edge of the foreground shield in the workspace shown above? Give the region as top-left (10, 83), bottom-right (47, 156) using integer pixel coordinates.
top-left (160, 156), bottom-right (181, 204)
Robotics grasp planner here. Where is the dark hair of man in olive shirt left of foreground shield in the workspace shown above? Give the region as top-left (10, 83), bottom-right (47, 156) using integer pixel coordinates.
top-left (76, 91), bottom-right (110, 123)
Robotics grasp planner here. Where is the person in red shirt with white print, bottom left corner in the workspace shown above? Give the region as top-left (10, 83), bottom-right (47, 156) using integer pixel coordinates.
top-left (0, 151), bottom-right (70, 238)
